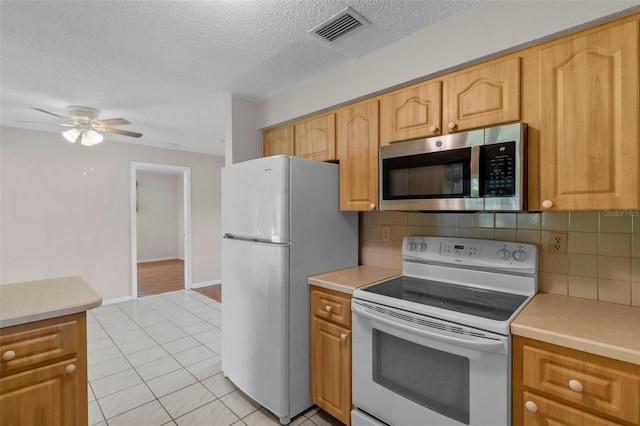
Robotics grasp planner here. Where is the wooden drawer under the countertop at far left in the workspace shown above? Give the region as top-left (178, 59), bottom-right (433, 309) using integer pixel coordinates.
top-left (0, 321), bottom-right (78, 377)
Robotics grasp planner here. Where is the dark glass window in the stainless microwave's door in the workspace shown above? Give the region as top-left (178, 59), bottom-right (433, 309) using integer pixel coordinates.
top-left (382, 148), bottom-right (471, 200)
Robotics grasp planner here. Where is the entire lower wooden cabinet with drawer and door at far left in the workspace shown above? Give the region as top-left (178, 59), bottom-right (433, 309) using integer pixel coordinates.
top-left (0, 312), bottom-right (88, 426)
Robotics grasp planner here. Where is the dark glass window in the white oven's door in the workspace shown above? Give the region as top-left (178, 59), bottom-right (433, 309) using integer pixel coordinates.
top-left (373, 329), bottom-right (469, 425)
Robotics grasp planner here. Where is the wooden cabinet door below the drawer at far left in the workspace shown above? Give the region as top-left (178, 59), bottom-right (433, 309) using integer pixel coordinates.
top-left (0, 359), bottom-right (79, 426)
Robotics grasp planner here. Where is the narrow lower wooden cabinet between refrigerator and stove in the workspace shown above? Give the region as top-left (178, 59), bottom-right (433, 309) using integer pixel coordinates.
top-left (311, 286), bottom-right (351, 425)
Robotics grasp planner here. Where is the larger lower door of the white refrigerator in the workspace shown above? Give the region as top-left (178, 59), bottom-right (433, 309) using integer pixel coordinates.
top-left (222, 239), bottom-right (290, 418)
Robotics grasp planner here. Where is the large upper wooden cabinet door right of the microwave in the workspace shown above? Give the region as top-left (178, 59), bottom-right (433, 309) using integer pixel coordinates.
top-left (540, 21), bottom-right (640, 210)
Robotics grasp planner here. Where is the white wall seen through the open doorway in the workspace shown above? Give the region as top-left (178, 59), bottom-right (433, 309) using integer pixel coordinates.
top-left (136, 171), bottom-right (184, 263)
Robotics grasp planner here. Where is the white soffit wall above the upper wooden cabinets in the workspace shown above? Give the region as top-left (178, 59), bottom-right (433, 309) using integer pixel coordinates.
top-left (256, 0), bottom-right (639, 129)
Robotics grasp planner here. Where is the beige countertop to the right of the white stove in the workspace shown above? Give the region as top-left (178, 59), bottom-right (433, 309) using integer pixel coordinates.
top-left (511, 293), bottom-right (640, 365)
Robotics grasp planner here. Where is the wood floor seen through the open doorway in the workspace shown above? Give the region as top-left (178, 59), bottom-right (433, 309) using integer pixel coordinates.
top-left (138, 259), bottom-right (184, 297)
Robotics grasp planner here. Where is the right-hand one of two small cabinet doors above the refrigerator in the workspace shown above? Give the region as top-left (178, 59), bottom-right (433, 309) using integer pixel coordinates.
top-left (294, 113), bottom-right (336, 161)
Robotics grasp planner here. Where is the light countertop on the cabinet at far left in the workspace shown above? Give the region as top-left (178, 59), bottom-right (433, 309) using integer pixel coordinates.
top-left (0, 277), bottom-right (102, 327)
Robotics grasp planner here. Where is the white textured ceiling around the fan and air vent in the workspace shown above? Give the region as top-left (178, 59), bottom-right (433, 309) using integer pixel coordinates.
top-left (0, 0), bottom-right (477, 155)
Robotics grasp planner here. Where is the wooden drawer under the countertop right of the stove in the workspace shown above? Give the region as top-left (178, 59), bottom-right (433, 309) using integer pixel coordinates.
top-left (523, 345), bottom-right (640, 424)
